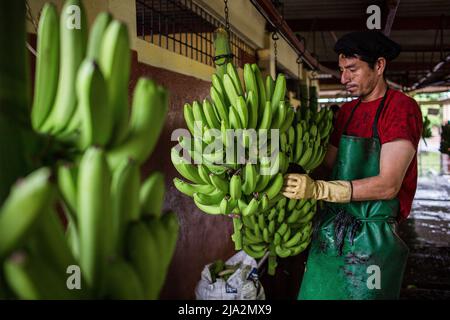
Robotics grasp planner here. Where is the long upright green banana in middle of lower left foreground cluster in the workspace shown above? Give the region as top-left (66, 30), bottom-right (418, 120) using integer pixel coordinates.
top-left (77, 147), bottom-right (112, 293)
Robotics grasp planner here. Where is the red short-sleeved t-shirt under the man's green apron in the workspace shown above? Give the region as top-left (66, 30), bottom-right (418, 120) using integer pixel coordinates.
top-left (330, 89), bottom-right (422, 221)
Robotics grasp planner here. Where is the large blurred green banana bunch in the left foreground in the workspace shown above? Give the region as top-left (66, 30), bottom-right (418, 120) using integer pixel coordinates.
top-left (0, 0), bottom-right (179, 299)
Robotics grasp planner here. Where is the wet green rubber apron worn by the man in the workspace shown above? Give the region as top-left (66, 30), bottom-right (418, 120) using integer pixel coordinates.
top-left (298, 89), bottom-right (409, 300)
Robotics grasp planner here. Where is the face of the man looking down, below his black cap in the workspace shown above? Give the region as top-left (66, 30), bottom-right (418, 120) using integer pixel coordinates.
top-left (339, 54), bottom-right (379, 96)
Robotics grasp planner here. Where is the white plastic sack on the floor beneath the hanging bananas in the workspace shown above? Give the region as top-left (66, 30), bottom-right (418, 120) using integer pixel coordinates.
top-left (195, 250), bottom-right (265, 300)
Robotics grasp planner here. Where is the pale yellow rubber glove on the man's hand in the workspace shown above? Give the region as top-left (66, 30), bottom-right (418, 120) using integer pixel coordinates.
top-left (282, 173), bottom-right (352, 203)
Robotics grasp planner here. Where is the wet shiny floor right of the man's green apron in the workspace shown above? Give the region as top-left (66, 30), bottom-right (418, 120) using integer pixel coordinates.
top-left (399, 175), bottom-right (450, 299)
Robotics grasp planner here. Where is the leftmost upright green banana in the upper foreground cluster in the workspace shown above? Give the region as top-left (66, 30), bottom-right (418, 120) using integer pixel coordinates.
top-left (31, 3), bottom-right (60, 131)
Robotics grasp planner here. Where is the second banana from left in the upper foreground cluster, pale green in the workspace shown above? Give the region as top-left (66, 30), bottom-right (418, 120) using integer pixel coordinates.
top-left (41, 0), bottom-right (88, 133)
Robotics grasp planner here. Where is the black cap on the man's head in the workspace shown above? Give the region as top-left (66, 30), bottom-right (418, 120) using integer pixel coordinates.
top-left (334, 30), bottom-right (402, 62)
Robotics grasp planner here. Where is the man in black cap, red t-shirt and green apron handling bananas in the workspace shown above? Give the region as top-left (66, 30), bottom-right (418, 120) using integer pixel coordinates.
top-left (283, 31), bottom-right (422, 299)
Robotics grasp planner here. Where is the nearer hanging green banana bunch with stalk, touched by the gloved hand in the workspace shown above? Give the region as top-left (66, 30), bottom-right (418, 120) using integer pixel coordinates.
top-left (171, 29), bottom-right (295, 255)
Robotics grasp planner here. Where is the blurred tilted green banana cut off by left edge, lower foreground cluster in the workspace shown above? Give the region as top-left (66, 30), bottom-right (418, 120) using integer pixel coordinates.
top-left (0, 168), bottom-right (55, 261)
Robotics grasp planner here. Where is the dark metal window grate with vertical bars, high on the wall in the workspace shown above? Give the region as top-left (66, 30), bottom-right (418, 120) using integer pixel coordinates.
top-left (136, 0), bottom-right (256, 67)
